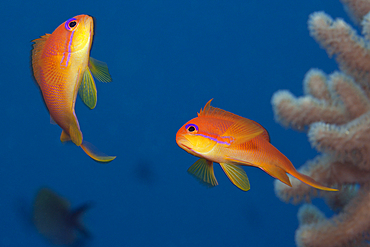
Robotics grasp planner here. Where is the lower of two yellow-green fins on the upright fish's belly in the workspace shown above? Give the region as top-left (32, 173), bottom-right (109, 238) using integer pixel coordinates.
top-left (78, 68), bottom-right (97, 109)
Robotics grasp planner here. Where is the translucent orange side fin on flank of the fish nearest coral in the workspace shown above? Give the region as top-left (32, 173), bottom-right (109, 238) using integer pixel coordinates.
top-left (222, 119), bottom-right (265, 145)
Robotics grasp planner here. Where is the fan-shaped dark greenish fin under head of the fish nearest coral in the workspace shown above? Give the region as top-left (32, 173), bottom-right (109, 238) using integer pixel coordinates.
top-left (188, 159), bottom-right (218, 187)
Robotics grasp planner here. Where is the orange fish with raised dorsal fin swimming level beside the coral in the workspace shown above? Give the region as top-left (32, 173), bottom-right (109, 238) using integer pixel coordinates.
top-left (176, 100), bottom-right (337, 191)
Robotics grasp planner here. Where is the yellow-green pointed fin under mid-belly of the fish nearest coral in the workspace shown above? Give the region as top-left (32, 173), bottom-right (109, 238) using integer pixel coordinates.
top-left (220, 163), bottom-right (251, 191)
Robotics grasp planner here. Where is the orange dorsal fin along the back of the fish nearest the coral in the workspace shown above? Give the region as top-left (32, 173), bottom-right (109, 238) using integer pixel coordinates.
top-left (198, 99), bottom-right (270, 142)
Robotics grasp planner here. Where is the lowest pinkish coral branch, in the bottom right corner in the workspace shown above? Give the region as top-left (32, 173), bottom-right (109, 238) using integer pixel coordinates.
top-left (296, 188), bottom-right (370, 247)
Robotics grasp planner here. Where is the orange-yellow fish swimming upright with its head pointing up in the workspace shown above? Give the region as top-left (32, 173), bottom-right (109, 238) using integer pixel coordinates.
top-left (32, 15), bottom-right (115, 162)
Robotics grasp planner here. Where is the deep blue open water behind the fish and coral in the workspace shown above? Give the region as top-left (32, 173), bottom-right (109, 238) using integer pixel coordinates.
top-left (0, 0), bottom-right (346, 247)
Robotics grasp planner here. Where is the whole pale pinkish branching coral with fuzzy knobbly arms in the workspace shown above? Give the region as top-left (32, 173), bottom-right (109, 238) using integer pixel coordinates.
top-left (272, 0), bottom-right (370, 246)
